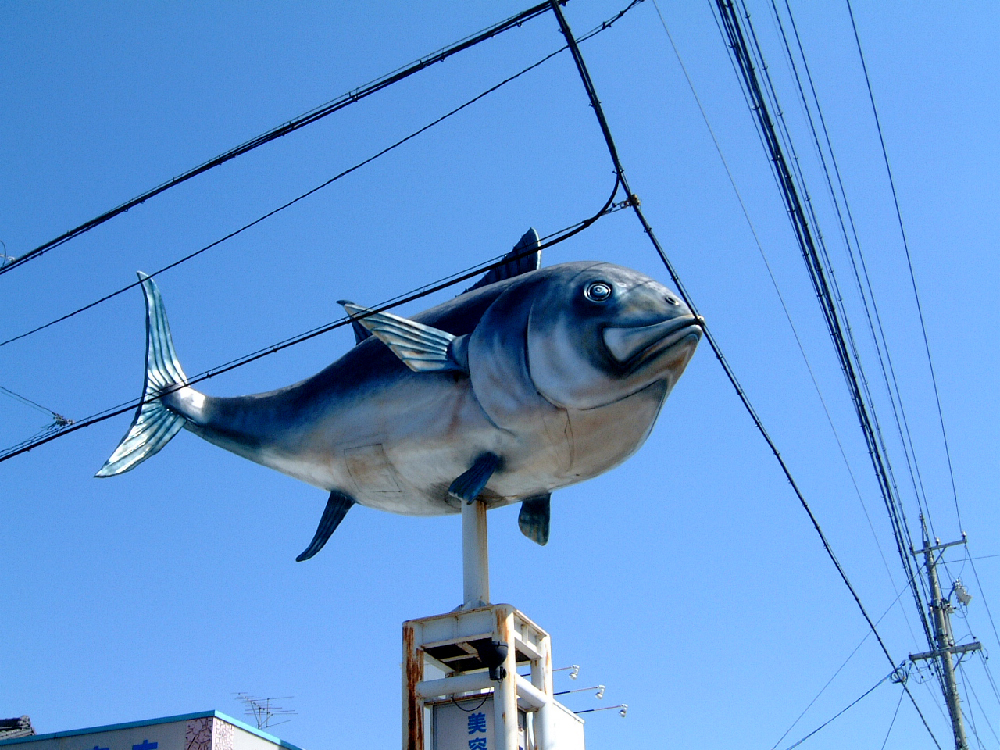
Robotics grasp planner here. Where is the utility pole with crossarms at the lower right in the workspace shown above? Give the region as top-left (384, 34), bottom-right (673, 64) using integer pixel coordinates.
top-left (910, 514), bottom-right (982, 750)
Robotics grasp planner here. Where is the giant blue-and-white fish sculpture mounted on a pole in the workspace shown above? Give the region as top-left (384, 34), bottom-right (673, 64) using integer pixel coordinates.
top-left (97, 230), bottom-right (704, 561)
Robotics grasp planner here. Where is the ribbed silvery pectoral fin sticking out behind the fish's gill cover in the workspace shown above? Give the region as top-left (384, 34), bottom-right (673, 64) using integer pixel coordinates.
top-left (340, 300), bottom-right (468, 373)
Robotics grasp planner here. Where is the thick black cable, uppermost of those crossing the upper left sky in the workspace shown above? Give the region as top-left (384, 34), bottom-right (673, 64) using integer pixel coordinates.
top-left (0, 0), bottom-right (556, 275)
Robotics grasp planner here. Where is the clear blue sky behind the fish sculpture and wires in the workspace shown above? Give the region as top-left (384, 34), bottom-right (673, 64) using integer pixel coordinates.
top-left (0, 0), bottom-right (1000, 750)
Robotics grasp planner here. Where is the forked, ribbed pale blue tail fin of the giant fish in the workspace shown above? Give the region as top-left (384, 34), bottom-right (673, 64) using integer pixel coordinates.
top-left (95, 271), bottom-right (187, 477)
